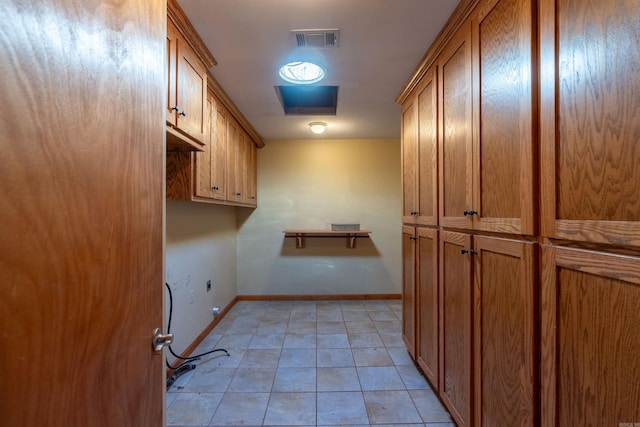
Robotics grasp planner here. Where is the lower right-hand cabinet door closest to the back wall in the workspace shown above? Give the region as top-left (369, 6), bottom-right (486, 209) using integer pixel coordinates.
top-left (402, 226), bottom-right (416, 359)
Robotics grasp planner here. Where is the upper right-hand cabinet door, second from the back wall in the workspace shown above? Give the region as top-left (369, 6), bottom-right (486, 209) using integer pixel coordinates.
top-left (416, 66), bottom-right (438, 225)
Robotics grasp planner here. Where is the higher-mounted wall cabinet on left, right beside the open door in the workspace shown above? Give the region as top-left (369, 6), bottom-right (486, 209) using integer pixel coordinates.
top-left (167, 20), bottom-right (208, 151)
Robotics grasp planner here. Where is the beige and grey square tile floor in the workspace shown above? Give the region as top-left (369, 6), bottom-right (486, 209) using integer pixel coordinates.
top-left (167, 300), bottom-right (454, 427)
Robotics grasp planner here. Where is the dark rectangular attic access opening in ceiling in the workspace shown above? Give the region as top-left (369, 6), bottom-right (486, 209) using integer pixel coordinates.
top-left (276, 86), bottom-right (338, 116)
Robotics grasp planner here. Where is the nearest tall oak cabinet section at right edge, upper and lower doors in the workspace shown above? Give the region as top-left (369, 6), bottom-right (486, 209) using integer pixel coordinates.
top-left (540, 0), bottom-right (640, 426)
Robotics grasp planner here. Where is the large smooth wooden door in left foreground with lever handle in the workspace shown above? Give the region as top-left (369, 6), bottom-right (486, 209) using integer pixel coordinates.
top-left (0, 0), bottom-right (166, 427)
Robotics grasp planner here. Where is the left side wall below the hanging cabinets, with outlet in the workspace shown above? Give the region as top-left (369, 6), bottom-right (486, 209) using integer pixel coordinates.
top-left (165, 202), bottom-right (241, 360)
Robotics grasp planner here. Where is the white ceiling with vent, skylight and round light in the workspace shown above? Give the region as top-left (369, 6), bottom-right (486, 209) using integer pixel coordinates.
top-left (178, 0), bottom-right (458, 141)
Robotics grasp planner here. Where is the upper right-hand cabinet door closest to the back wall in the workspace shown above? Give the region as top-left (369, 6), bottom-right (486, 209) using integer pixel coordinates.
top-left (401, 96), bottom-right (418, 224)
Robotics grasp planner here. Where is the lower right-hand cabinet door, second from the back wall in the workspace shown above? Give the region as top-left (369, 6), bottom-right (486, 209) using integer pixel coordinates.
top-left (416, 228), bottom-right (439, 389)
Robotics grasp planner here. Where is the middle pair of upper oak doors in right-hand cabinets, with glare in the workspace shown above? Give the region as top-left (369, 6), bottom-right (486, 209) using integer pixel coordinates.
top-left (437, 0), bottom-right (537, 235)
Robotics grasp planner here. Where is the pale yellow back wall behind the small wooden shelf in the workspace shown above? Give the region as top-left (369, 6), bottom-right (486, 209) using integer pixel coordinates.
top-left (237, 139), bottom-right (402, 295)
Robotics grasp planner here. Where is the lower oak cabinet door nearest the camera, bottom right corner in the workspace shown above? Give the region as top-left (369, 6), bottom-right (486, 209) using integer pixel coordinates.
top-left (541, 246), bottom-right (640, 427)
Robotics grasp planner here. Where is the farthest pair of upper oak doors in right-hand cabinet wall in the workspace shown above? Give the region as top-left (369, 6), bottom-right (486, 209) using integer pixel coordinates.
top-left (402, 67), bottom-right (438, 225)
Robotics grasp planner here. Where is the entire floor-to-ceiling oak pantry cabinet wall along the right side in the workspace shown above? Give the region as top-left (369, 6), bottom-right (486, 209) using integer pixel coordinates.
top-left (398, 0), bottom-right (640, 426)
